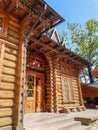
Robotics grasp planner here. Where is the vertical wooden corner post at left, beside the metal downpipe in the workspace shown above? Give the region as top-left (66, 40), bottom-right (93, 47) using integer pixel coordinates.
top-left (13, 38), bottom-right (24, 130)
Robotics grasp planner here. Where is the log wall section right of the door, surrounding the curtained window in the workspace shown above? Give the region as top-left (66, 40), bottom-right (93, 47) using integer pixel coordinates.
top-left (45, 57), bottom-right (83, 112)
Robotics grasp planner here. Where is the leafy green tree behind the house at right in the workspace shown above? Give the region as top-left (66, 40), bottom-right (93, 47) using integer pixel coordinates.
top-left (60, 19), bottom-right (98, 83)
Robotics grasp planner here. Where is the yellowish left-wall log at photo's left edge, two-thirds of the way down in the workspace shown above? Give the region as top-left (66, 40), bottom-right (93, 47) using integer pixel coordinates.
top-left (0, 82), bottom-right (16, 91)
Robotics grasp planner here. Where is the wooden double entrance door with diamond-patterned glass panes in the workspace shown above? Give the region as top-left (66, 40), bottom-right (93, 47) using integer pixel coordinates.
top-left (25, 72), bottom-right (45, 113)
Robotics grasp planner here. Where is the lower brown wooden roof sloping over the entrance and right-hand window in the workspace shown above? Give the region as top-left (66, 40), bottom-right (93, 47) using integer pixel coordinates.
top-left (28, 35), bottom-right (91, 68)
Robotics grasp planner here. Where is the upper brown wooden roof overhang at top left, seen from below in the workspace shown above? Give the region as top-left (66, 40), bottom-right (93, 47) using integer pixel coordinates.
top-left (0, 0), bottom-right (64, 38)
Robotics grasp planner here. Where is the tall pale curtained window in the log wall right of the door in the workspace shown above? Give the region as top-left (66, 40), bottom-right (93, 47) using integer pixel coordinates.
top-left (62, 76), bottom-right (74, 102)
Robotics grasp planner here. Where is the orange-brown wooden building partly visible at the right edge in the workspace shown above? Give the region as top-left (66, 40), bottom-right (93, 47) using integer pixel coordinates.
top-left (81, 64), bottom-right (98, 108)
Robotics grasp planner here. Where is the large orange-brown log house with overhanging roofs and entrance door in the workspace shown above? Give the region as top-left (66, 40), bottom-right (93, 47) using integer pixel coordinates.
top-left (0, 0), bottom-right (89, 130)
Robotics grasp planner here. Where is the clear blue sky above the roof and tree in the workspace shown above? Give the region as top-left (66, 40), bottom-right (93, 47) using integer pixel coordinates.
top-left (45, 0), bottom-right (98, 32)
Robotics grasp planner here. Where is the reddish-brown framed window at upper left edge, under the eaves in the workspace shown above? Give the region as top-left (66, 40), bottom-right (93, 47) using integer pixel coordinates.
top-left (0, 12), bottom-right (8, 37)
